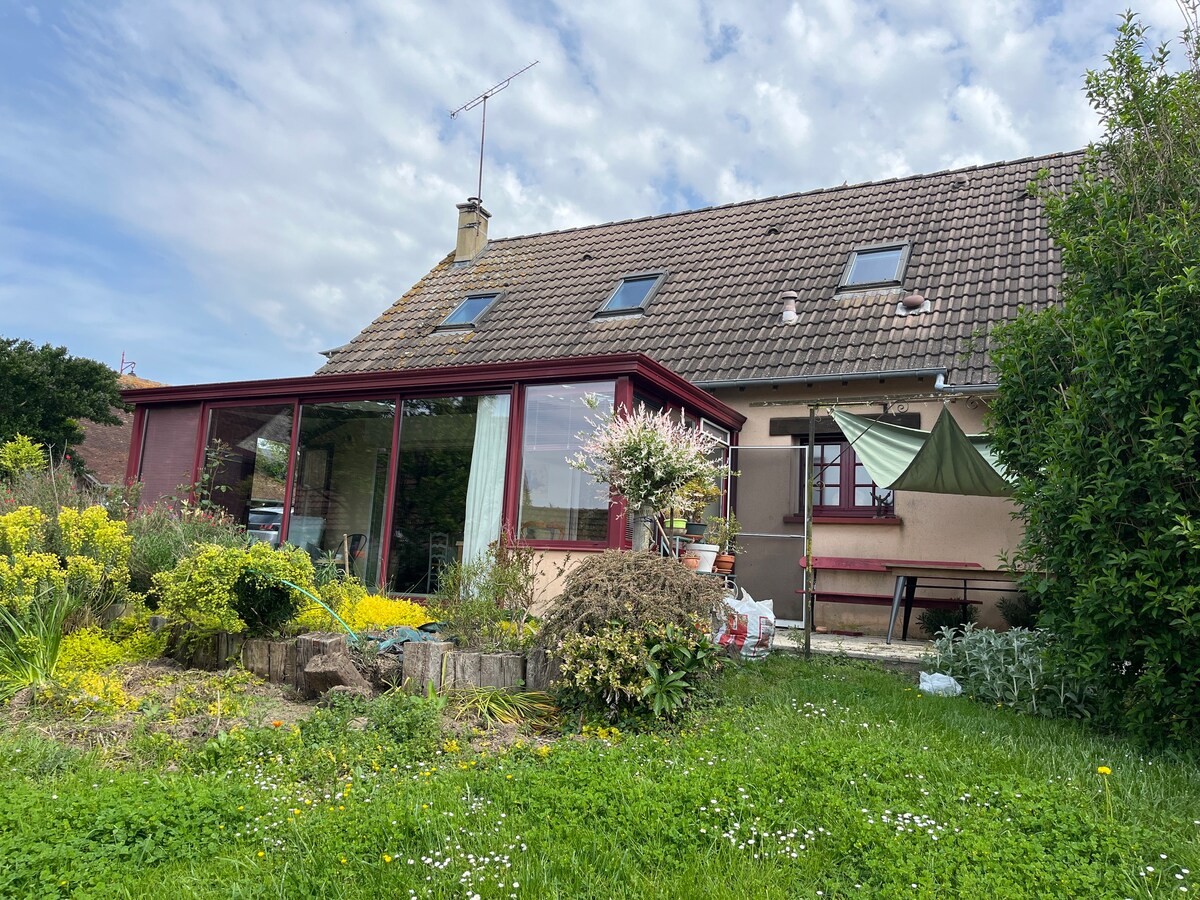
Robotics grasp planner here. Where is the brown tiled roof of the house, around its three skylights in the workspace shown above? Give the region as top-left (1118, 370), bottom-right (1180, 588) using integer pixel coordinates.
top-left (319, 152), bottom-right (1081, 384)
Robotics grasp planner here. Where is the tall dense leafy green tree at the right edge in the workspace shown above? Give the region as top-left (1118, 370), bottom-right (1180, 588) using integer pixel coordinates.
top-left (991, 14), bottom-right (1200, 744)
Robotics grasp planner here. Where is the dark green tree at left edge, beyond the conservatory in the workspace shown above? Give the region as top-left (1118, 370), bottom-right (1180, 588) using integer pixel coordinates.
top-left (0, 337), bottom-right (125, 465)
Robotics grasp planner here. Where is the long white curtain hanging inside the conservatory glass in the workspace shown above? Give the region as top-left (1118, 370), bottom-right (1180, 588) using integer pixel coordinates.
top-left (462, 394), bottom-right (509, 563)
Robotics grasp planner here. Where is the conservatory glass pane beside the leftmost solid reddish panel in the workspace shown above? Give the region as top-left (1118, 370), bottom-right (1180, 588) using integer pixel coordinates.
top-left (203, 403), bottom-right (292, 546)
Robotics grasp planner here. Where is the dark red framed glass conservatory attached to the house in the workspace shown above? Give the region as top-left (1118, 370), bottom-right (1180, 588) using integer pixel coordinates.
top-left (124, 354), bottom-right (744, 595)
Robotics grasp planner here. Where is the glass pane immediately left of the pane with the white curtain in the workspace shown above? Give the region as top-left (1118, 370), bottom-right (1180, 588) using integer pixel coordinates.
top-left (288, 401), bottom-right (396, 583)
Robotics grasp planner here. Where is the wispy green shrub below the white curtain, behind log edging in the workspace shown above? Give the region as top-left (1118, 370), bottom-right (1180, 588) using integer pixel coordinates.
top-left (432, 529), bottom-right (538, 650)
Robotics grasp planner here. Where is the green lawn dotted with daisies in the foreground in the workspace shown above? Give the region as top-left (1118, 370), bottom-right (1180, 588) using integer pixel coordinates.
top-left (0, 656), bottom-right (1200, 900)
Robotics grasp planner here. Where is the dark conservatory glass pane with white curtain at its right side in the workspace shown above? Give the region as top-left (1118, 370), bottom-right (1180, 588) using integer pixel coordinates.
top-left (388, 394), bottom-right (510, 594)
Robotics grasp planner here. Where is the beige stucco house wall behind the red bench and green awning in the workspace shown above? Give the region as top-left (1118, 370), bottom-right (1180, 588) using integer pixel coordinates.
top-left (714, 379), bottom-right (1020, 634)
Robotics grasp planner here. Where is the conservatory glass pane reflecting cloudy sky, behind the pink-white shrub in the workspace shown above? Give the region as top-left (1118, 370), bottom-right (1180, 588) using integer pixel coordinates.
top-left (518, 382), bottom-right (614, 541)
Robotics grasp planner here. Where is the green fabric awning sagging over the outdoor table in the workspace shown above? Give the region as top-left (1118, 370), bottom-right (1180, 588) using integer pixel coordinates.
top-left (833, 407), bottom-right (1013, 497)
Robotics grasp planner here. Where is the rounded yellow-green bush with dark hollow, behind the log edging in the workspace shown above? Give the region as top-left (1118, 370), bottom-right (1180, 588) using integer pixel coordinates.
top-left (154, 542), bottom-right (316, 635)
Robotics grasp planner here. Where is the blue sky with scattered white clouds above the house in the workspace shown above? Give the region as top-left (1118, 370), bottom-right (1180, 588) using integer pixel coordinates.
top-left (0, 0), bottom-right (1183, 384)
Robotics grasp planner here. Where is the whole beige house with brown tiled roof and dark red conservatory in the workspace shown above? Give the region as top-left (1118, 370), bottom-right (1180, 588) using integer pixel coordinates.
top-left (126, 146), bottom-right (1081, 630)
